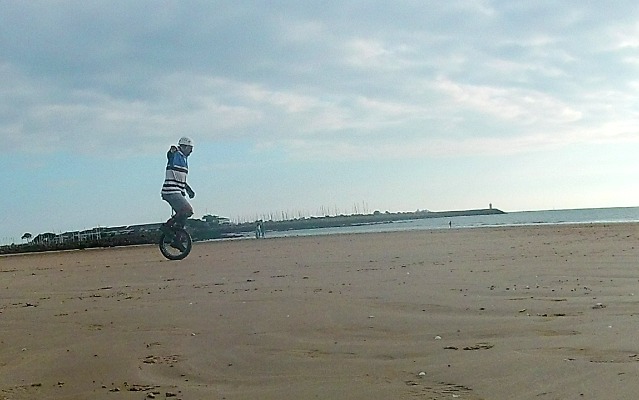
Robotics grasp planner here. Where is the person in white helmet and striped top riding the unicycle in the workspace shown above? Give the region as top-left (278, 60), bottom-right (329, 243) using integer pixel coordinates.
top-left (160, 137), bottom-right (195, 232)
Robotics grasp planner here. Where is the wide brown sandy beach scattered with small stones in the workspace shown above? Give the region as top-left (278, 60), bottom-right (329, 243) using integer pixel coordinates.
top-left (0, 224), bottom-right (639, 400)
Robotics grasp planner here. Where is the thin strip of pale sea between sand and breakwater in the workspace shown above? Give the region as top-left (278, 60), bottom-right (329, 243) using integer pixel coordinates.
top-left (266, 207), bottom-right (639, 237)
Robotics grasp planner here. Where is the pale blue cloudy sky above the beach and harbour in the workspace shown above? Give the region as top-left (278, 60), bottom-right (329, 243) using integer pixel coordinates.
top-left (0, 0), bottom-right (639, 243)
